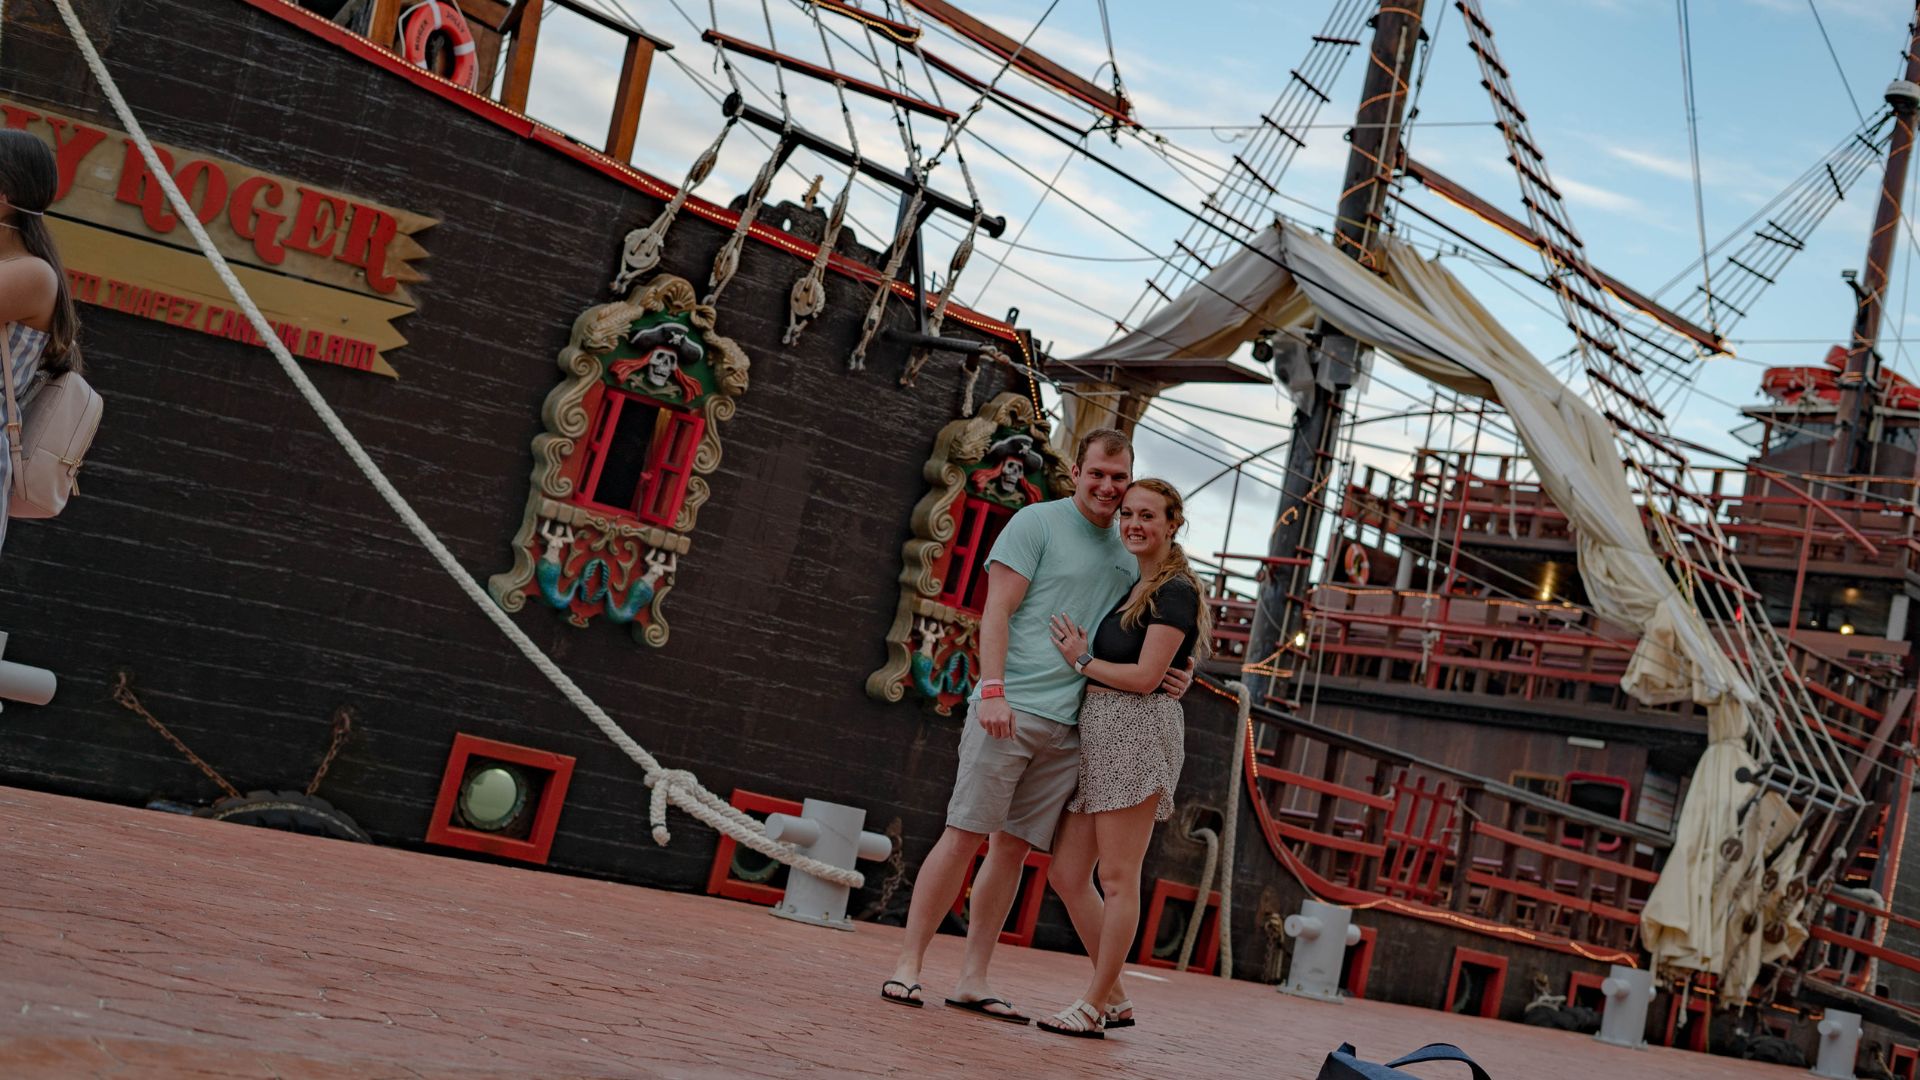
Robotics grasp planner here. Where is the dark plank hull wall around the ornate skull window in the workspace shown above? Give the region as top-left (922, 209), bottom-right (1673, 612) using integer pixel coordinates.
top-left (0, 0), bottom-right (1274, 940)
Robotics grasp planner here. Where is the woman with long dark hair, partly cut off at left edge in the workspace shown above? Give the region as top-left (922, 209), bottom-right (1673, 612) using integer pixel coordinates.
top-left (0, 131), bottom-right (81, 542)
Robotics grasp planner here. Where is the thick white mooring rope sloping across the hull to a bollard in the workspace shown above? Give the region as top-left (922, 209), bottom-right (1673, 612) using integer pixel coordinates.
top-left (54, 0), bottom-right (866, 888)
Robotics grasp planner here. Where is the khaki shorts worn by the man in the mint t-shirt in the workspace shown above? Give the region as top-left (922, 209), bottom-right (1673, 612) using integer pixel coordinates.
top-left (947, 709), bottom-right (1079, 851)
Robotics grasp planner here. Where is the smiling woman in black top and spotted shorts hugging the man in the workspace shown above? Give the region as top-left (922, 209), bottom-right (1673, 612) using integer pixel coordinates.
top-left (1041, 480), bottom-right (1208, 1038)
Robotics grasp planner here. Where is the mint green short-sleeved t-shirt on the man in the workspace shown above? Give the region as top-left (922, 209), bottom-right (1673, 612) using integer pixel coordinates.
top-left (975, 500), bottom-right (1140, 724)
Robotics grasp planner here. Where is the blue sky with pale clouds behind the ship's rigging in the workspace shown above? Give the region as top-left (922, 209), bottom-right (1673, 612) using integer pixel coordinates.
top-left (503, 0), bottom-right (1920, 588)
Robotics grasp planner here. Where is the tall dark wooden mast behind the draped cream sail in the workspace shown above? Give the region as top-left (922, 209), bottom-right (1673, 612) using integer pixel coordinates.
top-left (1246, 0), bottom-right (1425, 701)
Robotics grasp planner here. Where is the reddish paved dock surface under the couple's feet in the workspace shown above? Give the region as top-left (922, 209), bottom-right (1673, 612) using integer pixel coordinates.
top-left (0, 788), bottom-right (1805, 1080)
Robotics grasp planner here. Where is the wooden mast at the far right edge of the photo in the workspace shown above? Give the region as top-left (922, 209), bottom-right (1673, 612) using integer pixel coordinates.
top-left (1826, 6), bottom-right (1920, 475)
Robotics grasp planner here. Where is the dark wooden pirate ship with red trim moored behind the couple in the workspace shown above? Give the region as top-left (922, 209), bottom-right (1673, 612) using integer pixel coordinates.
top-left (11, 0), bottom-right (1920, 1076)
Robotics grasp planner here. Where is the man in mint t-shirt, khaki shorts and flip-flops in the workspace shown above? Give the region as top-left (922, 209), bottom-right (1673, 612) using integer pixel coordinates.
top-left (879, 429), bottom-right (1192, 1024)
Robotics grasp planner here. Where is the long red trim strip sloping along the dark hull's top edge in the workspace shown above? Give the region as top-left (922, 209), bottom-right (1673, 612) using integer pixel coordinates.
top-left (240, 0), bottom-right (1020, 344)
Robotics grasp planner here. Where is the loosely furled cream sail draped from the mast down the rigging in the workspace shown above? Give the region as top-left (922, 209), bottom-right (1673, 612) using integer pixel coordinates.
top-left (1075, 225), bottom-right (1758, 999)
